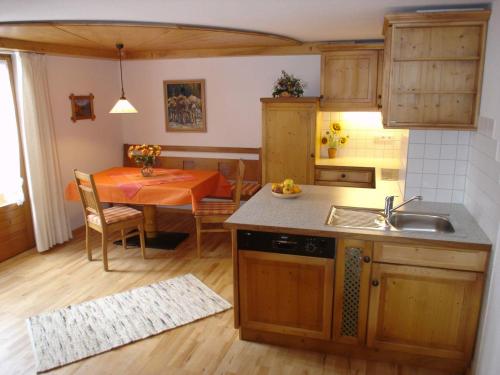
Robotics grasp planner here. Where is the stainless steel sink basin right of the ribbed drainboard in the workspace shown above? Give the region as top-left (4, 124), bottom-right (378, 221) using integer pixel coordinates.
top-left (388, 212), bottom-right (455, 233)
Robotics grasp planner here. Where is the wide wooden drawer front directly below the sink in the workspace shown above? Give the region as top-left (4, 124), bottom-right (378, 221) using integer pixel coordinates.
top-left (373, 242), bottom-right (488, 272)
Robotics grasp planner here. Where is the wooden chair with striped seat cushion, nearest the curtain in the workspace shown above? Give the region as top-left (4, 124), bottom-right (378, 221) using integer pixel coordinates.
top-left (73, 169), bottom-right (146, 271)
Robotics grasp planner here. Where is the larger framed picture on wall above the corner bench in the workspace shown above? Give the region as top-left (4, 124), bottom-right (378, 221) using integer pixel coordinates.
top-left (163, 79), bottom-right (207, 132)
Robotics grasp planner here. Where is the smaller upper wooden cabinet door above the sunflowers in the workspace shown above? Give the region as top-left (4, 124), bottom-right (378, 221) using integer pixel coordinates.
top-left (320, 50), bottom-right (379, 111)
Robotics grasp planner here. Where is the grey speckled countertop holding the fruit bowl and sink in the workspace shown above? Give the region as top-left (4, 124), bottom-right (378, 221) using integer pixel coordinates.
top-left (224, 184), bottom-right (491, 250)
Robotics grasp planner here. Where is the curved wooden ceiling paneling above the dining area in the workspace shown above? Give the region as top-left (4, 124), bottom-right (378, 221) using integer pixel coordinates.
top-left (0, 22), bottom-right (306, 59)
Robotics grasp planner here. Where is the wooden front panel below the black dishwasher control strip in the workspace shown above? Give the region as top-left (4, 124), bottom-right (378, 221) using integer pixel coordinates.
top-left (239, 250), bottom-right (334, 339)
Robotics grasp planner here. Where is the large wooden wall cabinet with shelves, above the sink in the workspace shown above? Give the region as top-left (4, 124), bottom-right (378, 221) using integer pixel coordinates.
top-left (382, 11), bottom-right (490, 129)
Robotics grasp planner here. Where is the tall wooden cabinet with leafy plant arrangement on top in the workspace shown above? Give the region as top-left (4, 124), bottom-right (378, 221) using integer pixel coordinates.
top-left (261, 98), bottom-right (319, 185)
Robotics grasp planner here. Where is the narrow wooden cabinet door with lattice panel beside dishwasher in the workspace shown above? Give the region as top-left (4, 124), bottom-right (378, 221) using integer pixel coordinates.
top-left (333, 239), bottom-right (373, 345)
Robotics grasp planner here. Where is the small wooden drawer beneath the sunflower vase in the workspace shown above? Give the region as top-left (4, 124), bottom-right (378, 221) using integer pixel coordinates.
top-left (315, 166), bottom-right (375, 188)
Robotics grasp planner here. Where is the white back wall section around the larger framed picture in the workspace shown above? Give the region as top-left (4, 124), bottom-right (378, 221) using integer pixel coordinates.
top-left (123, 56), bottom-right (320, 147)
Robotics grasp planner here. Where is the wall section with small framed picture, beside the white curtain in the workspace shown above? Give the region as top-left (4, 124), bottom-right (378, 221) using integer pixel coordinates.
top-left (47, 56), bottom-right (123, 229)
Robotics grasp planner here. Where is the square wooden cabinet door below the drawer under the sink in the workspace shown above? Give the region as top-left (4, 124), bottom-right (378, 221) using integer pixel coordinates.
top-left (367, 263), bottom-right (483, 360)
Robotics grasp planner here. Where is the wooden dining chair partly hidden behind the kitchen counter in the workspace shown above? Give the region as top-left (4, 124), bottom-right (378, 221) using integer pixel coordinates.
top-left (194, 160), bottom-right (245, 258)
